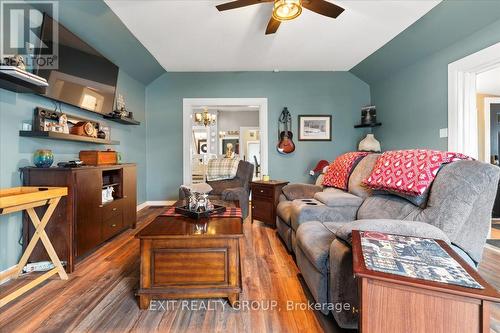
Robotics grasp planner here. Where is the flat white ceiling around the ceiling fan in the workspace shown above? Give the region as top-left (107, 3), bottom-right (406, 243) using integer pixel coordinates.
top-left (105, 0), bottom-right (440, 72)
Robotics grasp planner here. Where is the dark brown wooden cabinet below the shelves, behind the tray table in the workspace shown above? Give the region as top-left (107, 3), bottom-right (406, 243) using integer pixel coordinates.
top-left (23, 164), bottom-right (137, 273)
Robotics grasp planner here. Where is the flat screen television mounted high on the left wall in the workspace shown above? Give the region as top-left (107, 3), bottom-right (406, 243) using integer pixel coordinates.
top-left (36, 15), bottom-right (118, 114)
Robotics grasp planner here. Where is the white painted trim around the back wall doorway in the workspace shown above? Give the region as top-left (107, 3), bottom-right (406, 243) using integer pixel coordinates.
top-left (182, 98), bottom-right (269, 184)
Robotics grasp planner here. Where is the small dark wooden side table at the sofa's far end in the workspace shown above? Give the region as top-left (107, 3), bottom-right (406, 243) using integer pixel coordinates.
top-left (250, 180), bottom-right (288, 228)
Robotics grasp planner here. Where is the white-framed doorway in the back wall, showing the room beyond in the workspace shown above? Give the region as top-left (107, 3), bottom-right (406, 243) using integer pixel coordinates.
top-left (183, 98), bottom-right (268, 184)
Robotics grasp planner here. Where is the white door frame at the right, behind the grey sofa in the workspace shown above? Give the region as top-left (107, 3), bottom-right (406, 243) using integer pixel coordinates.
top-left (448, 43), bottom-right (500, 156)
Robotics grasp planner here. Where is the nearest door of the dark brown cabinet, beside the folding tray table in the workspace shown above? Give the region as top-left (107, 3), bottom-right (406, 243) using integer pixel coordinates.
top-left (75, 169), bottom-right (102, 257)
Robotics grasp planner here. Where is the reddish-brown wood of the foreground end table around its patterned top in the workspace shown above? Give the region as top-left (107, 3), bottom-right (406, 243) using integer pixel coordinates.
top-left (352, 230), bottom-right (500, 333)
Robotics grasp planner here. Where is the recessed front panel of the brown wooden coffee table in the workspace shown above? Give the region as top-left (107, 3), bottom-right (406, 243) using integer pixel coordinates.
top-left (152, 248), bottom-right (228, 287)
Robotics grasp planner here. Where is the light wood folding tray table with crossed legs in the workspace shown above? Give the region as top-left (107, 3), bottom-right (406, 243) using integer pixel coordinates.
top-left (0, 186), bottom-right (68, 307)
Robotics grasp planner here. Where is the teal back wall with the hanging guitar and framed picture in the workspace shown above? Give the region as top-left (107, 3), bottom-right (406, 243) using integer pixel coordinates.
top-left (146, 72), bottom-right (370, 200)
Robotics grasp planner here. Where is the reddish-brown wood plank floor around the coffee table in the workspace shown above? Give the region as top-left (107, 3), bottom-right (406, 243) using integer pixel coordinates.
top-left (0, 208), bottom-right (500, 333)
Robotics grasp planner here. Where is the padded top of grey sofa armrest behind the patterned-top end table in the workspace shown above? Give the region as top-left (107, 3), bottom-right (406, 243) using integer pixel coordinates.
top-left (336, 219), bottom-right (451, 244)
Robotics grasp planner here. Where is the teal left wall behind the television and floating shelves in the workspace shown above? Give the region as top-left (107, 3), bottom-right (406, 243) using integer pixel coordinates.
top-left (0, 0), bottom-right (156, 271)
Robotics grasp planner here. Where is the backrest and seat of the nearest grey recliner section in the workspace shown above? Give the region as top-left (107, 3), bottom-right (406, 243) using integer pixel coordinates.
top-left (357, 161), bottom-right (500, 262)
